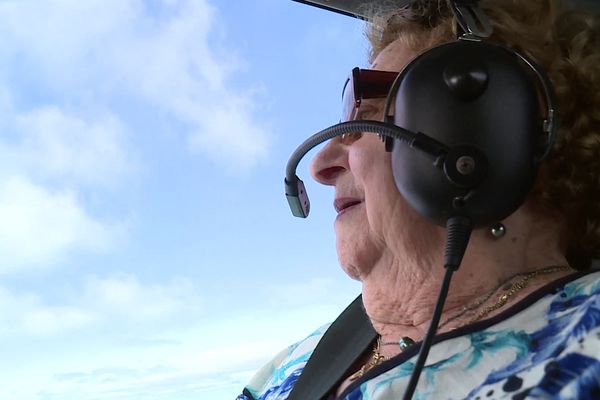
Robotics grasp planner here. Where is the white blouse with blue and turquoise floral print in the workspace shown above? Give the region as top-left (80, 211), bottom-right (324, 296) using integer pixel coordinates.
top-left (237, 272), bottom-right (600, 400)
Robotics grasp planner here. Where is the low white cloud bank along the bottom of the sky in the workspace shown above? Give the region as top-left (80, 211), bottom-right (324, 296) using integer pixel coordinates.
top-left (0, 284), bottom-right (352, 400)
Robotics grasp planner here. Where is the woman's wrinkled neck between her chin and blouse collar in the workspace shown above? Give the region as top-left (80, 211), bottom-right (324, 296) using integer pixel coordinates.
top-left (362, 206), bottom-right (570, 350)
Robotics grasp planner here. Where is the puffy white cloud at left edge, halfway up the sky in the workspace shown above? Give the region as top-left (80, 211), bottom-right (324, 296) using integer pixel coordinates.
top-left (0, 100), bottom-right (130, 274)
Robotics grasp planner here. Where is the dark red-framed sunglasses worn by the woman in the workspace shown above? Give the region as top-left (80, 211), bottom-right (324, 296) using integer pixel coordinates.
top-left (341, 67), bottom-right (398, 122)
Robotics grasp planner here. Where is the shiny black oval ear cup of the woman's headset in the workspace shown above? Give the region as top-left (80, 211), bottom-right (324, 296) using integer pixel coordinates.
top-left (386, 40), bottom-right (543, 226)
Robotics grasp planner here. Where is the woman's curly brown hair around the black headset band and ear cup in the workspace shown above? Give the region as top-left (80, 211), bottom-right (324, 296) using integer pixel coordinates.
top-left (366, 0), bottom-right (600, 269)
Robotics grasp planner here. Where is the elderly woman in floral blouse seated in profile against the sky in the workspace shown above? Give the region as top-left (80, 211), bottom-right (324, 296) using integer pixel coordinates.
top-left (238, 0), bottom-right (600, 400)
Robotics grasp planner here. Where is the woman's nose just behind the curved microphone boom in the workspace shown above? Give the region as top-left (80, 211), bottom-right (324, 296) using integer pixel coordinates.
top-left (310, 137), bottom-right (348, 186)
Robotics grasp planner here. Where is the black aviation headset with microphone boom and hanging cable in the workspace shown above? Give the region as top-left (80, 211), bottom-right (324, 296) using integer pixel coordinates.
top-left (285, 0), bottom-right (558, 399)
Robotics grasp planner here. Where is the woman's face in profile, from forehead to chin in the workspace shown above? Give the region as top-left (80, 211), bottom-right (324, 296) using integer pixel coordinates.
top-left (311, 41), bottom-right (439, 280)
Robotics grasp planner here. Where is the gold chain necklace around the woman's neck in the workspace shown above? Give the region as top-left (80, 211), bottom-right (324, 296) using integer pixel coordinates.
top-left (348, 266), bottom-right (569, 381)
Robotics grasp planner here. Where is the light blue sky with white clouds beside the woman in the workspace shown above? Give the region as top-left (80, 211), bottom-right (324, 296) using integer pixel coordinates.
top-left (0, 0), bottom-right (366, 400)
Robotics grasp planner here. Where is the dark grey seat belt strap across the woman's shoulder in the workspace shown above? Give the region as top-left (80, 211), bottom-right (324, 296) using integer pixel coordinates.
top-left (288, 296), bottom-right (377, 400)
